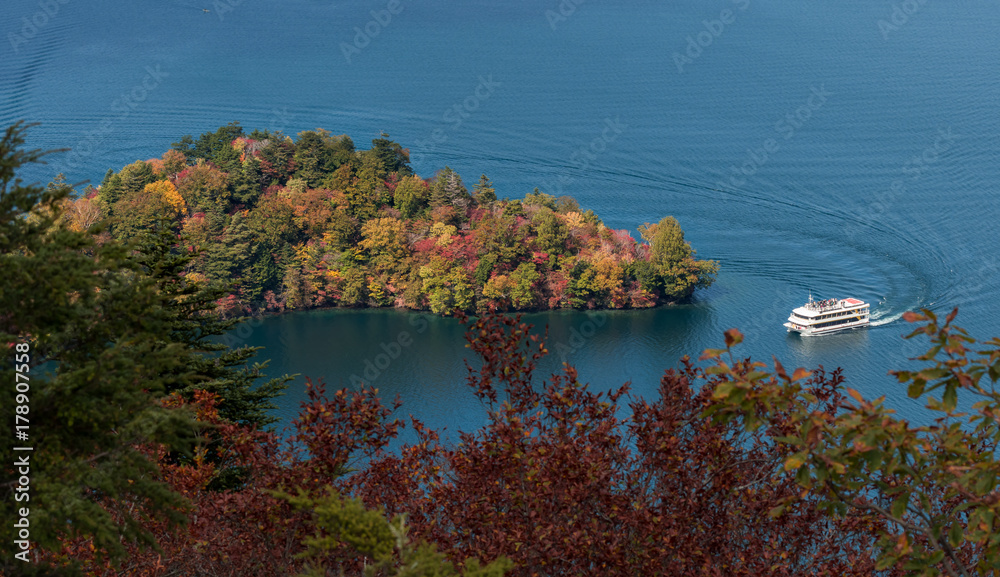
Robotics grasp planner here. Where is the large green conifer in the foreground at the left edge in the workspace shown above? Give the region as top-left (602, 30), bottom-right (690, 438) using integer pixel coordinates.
top-left (0, 124), bottom-right (197, 574)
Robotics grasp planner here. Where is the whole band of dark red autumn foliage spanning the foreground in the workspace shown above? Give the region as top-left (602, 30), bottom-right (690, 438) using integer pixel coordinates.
top-left (41, 314), bottom-right (900, 577)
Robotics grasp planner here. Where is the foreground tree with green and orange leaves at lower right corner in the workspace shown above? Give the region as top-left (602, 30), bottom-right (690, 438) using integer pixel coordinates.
top-left (705, 309), bottom-right (1000, 577)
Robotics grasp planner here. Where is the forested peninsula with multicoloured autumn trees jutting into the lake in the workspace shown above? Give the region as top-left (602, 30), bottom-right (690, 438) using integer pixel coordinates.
top-left (60, 122), bottom-right (718, 316)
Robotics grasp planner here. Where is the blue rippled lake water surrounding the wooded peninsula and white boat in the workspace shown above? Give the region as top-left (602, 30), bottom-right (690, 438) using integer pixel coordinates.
top-left (0, 0), bottom-right (1000, 428)
